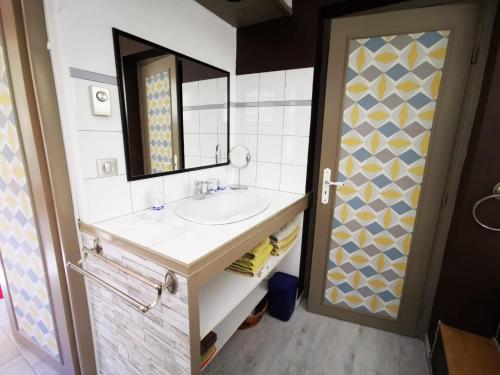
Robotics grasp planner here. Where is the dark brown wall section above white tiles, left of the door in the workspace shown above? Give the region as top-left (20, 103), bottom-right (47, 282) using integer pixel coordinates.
top-left (236, 0), bottom-right (342, 74)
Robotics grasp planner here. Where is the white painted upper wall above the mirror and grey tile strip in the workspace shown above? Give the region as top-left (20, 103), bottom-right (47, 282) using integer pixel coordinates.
top-left (52, 0), bottom-right (236, 76)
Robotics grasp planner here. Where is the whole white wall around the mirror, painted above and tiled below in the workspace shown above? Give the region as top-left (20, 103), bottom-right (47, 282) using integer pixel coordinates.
top-left (44, 0), bottom-right (236, 223)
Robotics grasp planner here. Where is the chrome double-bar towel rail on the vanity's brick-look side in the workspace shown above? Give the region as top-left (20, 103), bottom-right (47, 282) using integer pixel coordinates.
top-left (66, 241), bottom-right (177, 313)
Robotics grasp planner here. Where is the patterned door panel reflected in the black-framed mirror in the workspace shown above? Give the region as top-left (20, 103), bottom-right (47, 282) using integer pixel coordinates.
top-left (146, 72), bottom-right (174, 173)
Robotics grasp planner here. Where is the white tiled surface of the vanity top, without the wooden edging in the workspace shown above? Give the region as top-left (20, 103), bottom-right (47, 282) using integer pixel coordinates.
top-left (93, 188), bottom-right (304, 266)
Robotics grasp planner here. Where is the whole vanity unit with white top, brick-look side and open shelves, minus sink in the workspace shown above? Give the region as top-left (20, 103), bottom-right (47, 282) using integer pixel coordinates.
top-left (77, 188), bottom-right (309, 375)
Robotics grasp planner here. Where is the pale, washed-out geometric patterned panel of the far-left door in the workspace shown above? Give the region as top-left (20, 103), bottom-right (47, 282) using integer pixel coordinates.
top-left (0, 40), bottom-right (59, 359)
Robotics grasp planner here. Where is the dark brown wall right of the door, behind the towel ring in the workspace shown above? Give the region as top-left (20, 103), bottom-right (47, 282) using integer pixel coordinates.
top-left (429, 9), bottom-right (500, 337)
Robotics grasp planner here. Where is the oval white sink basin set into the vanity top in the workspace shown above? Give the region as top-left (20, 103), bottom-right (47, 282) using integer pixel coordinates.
top-left (175, 193), bottom-right (269, 224)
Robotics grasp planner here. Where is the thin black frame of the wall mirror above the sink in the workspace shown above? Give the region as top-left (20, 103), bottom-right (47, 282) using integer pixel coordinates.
top-left (112, 27), bottom-right (231, 181)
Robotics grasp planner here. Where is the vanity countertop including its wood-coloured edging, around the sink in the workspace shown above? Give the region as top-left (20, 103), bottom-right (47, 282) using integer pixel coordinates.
top-left (80, 188), bottom-right (308, 277)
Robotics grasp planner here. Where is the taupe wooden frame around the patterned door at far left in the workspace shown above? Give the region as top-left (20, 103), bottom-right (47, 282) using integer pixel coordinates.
top-left (0, 0), bottom-right (96, 375)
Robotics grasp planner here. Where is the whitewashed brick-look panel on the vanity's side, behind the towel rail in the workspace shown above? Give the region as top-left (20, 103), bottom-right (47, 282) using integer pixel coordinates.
top-left (85, 243), bottom-right (191, 375)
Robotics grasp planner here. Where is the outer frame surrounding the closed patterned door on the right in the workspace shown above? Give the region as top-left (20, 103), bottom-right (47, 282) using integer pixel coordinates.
top-left (304, 0), bottom-right (498, 339)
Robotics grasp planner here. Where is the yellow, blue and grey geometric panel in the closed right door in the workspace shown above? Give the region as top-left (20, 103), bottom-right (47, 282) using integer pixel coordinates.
top-left (324, 31), bottom-right (449, 319)
